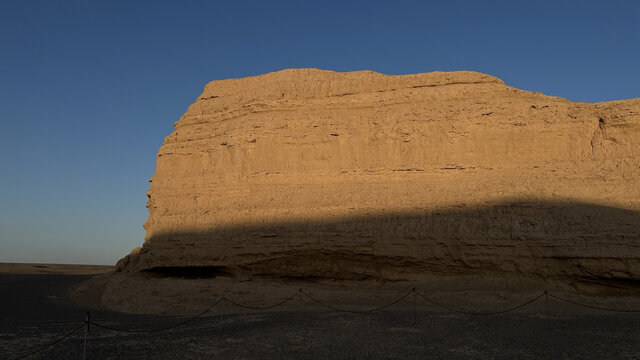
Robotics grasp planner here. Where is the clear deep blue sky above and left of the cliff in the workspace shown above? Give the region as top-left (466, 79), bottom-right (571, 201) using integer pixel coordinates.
top-left (0, 0), bottom-right (640, 264)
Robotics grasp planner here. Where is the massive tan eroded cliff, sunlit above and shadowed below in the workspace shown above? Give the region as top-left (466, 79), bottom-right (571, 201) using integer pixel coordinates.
top-left (118, 69), bottom-right (640, 280)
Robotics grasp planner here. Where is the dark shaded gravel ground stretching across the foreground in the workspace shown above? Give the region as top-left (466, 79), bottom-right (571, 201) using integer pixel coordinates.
top-left (0, 275), bottom-right (640, 359)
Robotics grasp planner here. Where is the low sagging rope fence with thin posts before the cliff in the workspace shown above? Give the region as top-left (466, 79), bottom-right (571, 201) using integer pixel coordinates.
top-left (12, 288), bottom-right (640, 360)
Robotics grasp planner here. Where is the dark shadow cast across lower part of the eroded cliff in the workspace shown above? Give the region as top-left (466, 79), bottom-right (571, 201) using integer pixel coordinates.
top-left (124, 199), bottom-right (640, 282)
